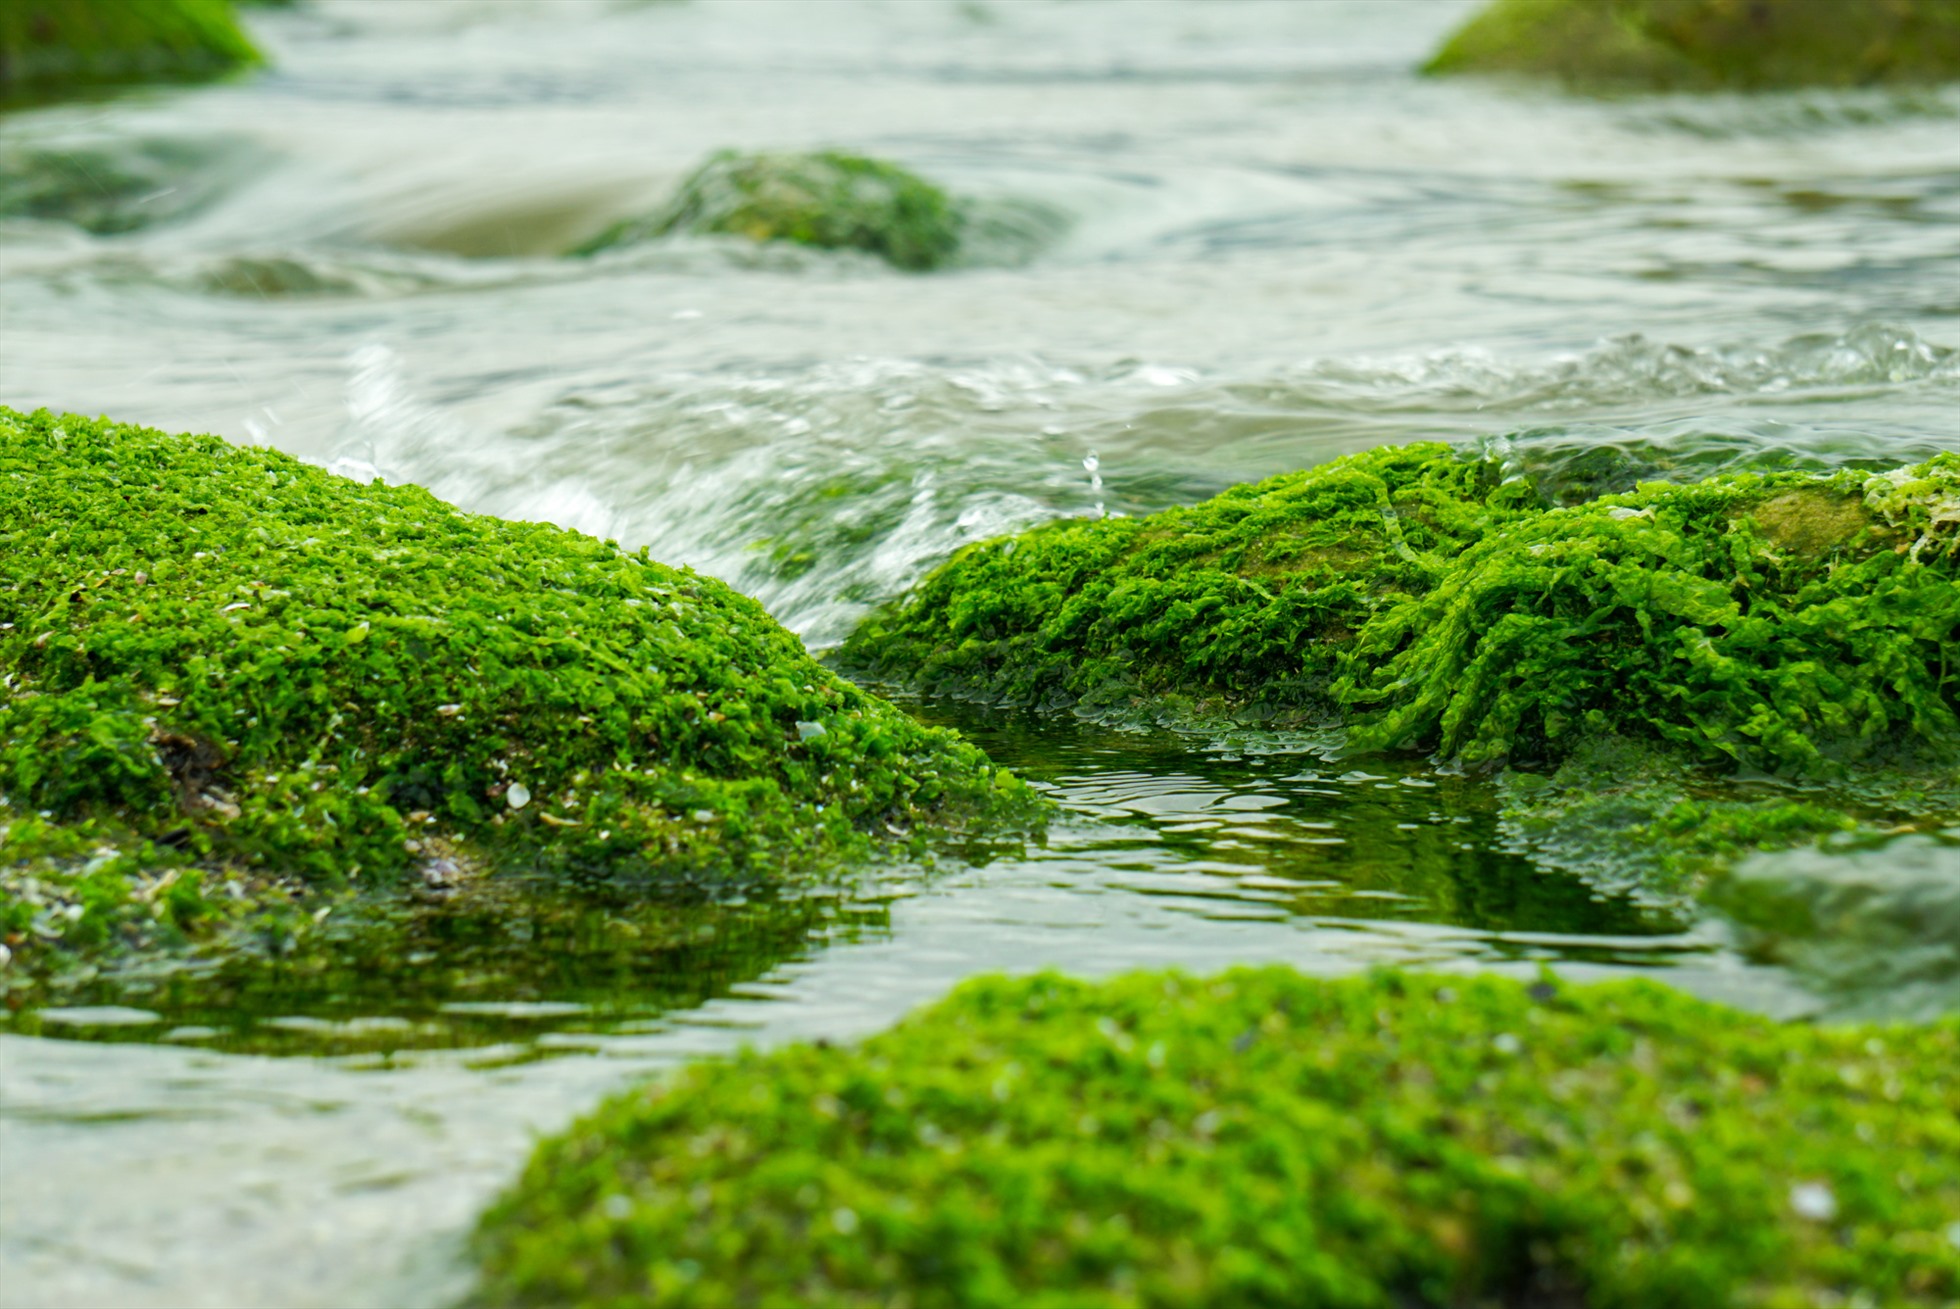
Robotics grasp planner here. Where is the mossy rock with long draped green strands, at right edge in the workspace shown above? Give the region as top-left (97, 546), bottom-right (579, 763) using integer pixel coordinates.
top-left (837, 445), bottom-right (1960, 774)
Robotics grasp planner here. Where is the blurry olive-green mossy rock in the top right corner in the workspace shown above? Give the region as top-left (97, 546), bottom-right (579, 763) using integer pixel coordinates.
top-left (1425, 0), bottom-right (1960, 90)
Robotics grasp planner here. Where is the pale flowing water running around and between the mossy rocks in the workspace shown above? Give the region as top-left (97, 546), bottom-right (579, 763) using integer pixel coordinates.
top-left (0, 0), bottom-right (1960, 1305)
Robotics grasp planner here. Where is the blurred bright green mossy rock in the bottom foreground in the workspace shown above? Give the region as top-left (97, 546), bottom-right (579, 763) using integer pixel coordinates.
top-left (476, 968), bottom-right (1960, 1309)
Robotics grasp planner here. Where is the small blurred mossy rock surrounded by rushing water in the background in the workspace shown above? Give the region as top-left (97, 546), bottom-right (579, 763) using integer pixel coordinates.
top-left (574, 151), bottom-right (960, 272)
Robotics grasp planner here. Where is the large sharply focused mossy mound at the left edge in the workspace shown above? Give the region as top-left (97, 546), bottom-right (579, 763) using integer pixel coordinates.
top-left (0, 410), bottom-right (1039, 979)
